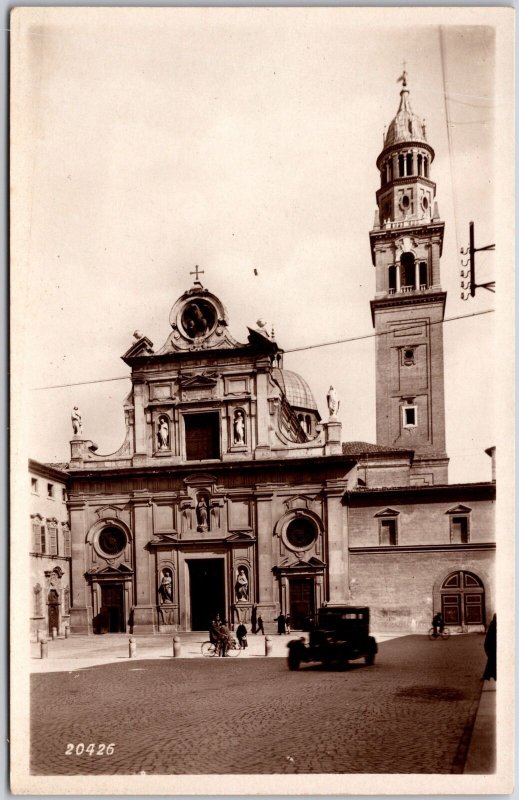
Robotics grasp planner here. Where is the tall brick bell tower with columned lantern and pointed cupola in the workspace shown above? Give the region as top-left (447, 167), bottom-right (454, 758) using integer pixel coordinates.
top-left (369, 71), bottom-right (448, 485)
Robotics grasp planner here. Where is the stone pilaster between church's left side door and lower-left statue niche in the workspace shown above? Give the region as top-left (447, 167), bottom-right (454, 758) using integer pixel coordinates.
top-left (132, 490), bottom-right (156, 633)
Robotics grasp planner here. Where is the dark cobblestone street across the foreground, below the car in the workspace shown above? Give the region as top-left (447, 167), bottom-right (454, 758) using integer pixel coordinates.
top-left (32, 635), bottom-right (485, 775)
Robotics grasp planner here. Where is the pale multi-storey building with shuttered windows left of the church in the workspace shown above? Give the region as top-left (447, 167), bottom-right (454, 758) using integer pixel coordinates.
top-left (29, 459), bottom-right (71, 635)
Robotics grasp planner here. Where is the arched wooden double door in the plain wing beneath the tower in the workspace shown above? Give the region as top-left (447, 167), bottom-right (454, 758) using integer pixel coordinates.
top-left (440, 570), bottom-right (485, 625)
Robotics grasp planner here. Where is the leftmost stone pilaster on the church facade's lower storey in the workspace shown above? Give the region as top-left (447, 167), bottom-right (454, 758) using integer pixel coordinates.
top-left (68, 500), bottom-right (93, 634)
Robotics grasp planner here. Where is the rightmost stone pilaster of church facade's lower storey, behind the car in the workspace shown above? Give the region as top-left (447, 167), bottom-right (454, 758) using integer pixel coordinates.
top-left (325, 481), bottom-right (349, 605)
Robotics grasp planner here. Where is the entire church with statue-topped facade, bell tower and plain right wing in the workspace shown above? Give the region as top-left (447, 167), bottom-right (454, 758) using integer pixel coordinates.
top-left (68, 76), bottom-right (495, 634)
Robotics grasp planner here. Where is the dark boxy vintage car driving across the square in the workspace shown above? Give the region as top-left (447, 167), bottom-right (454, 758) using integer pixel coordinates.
top-left (288, 606), bottom-right (378, 669)
